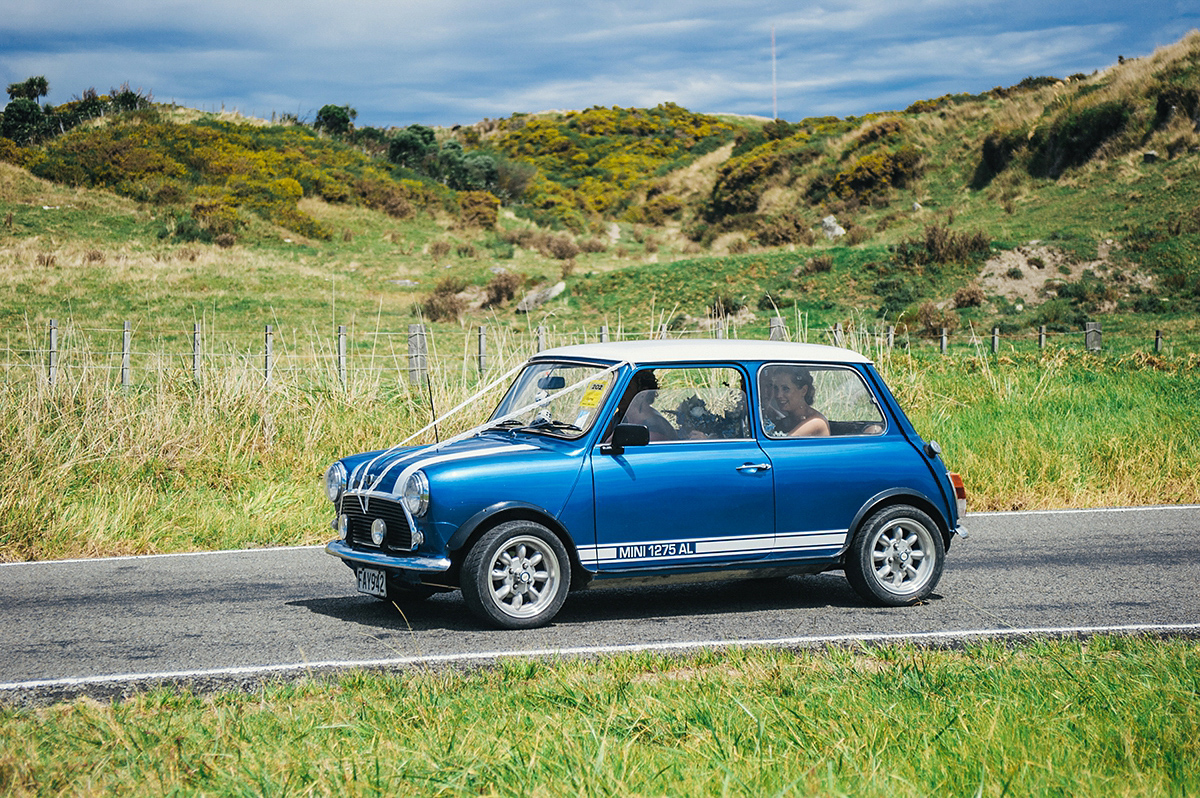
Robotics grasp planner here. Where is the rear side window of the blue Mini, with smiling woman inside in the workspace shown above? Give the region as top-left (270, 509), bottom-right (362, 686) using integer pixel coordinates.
top-left (758, 364), bottom-right (884, 438)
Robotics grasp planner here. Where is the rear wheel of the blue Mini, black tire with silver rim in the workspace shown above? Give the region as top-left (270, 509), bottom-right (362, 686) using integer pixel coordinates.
top-left (846, 504), bottom-right (946, 607)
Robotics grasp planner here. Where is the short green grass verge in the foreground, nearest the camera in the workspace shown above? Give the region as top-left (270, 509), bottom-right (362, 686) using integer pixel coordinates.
top-left (0, 637), bottom-right (1200, 797)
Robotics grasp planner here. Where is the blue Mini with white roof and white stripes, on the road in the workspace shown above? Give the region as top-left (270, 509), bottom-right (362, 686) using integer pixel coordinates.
top-left (325, 340), bottom-right (966, 629)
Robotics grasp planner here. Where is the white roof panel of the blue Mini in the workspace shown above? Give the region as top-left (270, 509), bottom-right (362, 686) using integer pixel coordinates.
top-left (535, 338), bottom-right (871, 364)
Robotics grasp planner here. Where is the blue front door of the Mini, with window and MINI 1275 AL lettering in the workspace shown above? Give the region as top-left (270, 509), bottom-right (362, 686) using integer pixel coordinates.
top-left (592, 366), bottom-right (774, 572)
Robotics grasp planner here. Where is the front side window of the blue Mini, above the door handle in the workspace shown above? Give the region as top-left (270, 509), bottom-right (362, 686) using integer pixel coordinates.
top-left (617, 367), bottom-right (750, 443)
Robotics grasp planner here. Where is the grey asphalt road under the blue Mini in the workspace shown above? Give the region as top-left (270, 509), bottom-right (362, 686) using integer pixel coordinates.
top-left (0, 506), bottom-right (1200, 700)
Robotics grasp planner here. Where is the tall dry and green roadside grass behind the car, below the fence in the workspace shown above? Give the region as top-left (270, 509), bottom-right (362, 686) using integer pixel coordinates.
top-left (0, 319), bottom-right (1200, 560)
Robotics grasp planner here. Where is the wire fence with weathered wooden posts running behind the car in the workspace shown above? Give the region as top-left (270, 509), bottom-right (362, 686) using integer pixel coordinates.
top-left (0, 317), bottom-right (1200, 386)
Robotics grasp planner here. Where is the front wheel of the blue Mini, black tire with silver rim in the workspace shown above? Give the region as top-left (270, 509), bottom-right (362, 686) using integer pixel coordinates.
top-left (461, 521), bottom-right (571, 629)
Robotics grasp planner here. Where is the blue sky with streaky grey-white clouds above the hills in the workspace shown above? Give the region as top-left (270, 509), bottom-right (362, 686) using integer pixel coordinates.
top-left (0, 0), bottom-right (1200, 127)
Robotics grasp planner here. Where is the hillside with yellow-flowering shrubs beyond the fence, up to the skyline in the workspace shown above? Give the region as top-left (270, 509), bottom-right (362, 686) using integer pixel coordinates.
top-left (0, 35), bottom-right (1200, 342)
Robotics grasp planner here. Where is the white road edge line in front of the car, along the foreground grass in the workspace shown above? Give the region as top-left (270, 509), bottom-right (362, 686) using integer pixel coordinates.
top-left (0, 623), bottom-right (1200, 690)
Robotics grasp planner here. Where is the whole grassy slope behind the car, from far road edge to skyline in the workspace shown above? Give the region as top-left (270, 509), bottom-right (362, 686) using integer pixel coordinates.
top-left (0, 35), bottom-right (1200, 559)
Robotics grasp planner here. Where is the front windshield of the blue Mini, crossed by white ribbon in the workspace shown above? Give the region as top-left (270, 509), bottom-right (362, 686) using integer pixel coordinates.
top-left (492, 362), bottom-right (617, 438)
